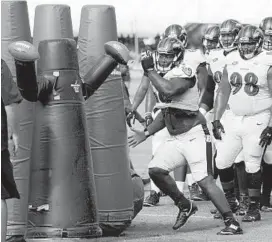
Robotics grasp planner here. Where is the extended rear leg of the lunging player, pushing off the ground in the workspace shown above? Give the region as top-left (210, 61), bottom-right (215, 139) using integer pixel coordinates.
top-left (184, 125), bottom-right (242, 235)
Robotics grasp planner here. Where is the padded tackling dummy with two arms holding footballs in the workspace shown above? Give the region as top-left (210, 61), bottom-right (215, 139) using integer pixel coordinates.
top-left (9, 39), bottom-right (128, 238)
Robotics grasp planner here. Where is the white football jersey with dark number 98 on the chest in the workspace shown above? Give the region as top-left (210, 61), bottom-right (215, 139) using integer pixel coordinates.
top-left (226, 52), bottom-right (272, 116)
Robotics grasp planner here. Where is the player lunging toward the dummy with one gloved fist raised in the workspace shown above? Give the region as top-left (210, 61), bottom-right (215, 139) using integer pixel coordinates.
top-left (128, 38), bottom-right (242, 235)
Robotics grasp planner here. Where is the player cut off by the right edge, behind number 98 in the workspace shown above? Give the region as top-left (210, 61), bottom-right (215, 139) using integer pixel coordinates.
top-left (259, 17), bottom-right (272, 212)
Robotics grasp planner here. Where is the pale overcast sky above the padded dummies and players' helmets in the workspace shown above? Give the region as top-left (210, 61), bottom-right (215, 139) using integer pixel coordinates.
top-left (27, 0), bottom-right (272, 36)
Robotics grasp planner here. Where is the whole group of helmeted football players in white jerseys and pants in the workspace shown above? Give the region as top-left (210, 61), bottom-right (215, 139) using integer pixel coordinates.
top-left (127, 17), bottom-right (272, 235)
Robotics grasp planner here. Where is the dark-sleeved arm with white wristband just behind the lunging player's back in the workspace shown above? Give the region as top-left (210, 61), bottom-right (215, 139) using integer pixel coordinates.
top-left (197, 65), bottom-right (215, 115)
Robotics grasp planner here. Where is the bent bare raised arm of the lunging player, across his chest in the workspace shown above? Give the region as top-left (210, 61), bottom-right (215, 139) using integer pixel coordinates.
top-left (147, 70), bottom-right (193, 98)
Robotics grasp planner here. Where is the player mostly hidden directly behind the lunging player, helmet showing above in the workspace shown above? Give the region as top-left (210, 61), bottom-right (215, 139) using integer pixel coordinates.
top-left (127, 24), bottom-right (210, 206)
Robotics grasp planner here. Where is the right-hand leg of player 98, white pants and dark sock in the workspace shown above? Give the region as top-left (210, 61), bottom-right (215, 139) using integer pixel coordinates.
top-left (242, 112), bottom-right (270, 222)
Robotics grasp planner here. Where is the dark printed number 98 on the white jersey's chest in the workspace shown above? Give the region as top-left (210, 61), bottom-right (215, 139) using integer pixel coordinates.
top-left (230, 72), bottom-right (259, 96)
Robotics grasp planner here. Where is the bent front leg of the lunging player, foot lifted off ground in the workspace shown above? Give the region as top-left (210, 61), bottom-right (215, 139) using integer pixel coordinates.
top-left (148, 137), bottom-right (197, 230)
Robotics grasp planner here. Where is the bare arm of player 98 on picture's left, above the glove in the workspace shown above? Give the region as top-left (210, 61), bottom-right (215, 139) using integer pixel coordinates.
top-left (214, 66), bottom-right (231, 120)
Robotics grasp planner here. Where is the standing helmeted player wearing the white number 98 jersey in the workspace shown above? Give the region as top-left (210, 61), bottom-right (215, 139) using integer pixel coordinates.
top-left (212, 25), bottom-right (272, 222)
